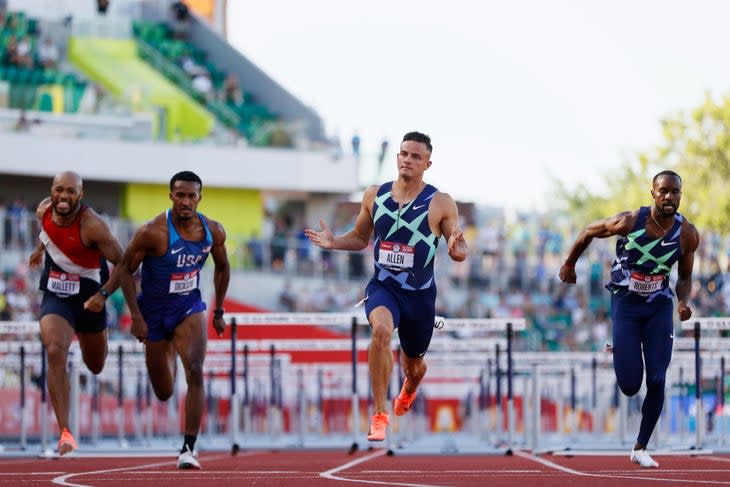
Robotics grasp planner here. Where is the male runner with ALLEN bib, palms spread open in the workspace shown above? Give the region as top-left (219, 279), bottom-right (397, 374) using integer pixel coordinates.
top-left (305, 132), bottom-right (468, 441)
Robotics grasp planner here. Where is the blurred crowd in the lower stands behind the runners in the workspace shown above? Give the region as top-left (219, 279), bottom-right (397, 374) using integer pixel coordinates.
top-left (0, 200), bottom-right (730, 351)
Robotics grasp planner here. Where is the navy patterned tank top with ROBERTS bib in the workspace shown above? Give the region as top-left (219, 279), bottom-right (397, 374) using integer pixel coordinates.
top-left (606, 206), bottom-right (684, 299)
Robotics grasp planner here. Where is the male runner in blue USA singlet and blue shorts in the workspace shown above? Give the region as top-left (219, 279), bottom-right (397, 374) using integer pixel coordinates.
top-left (88, 171), bottom-right (230, 469)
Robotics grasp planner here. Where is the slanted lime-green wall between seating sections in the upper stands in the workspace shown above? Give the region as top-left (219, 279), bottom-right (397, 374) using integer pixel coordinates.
top-left (69, 37), bottom-right (215, 140)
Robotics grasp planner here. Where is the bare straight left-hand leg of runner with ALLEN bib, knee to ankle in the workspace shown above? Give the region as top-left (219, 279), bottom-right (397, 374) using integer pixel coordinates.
top-left (368, 306), bottom-right (394, 414)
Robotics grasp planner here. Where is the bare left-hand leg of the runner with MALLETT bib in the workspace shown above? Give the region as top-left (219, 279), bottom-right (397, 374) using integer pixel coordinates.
top-left (40, 314), bottom-right (74, 431)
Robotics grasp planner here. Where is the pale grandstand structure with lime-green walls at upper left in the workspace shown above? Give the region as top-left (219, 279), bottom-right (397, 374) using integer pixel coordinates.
top-left (0, 0), bottom-right (358, 250)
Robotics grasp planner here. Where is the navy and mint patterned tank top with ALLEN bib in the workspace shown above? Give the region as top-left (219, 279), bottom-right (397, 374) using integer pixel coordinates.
top-left (372, 182), bottom-right (438, 290)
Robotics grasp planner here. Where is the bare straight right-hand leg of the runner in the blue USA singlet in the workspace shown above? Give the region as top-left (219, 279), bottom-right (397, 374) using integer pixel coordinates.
top-left (172, 312), bottom-right (208, 436)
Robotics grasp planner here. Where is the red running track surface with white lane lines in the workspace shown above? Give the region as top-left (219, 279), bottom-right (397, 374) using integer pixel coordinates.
top-left (0, 450), bottom-right (730, 487)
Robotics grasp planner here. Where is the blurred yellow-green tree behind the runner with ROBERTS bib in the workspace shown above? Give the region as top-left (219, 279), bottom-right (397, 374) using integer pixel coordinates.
top-left (553, 93), bottom-right (730, 233)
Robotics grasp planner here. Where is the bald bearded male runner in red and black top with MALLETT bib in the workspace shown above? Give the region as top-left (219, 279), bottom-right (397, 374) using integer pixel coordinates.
top-left (29, 171), bottom-right (135, 455)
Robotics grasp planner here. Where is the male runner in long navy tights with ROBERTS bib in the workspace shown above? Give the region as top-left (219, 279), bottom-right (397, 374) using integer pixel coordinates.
top-left (560, 171), bottom-right (700, 468)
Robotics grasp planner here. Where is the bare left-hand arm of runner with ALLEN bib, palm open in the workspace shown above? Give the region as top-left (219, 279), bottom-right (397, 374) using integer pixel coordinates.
top-left (304, 185), bottom-right (378, 250)
